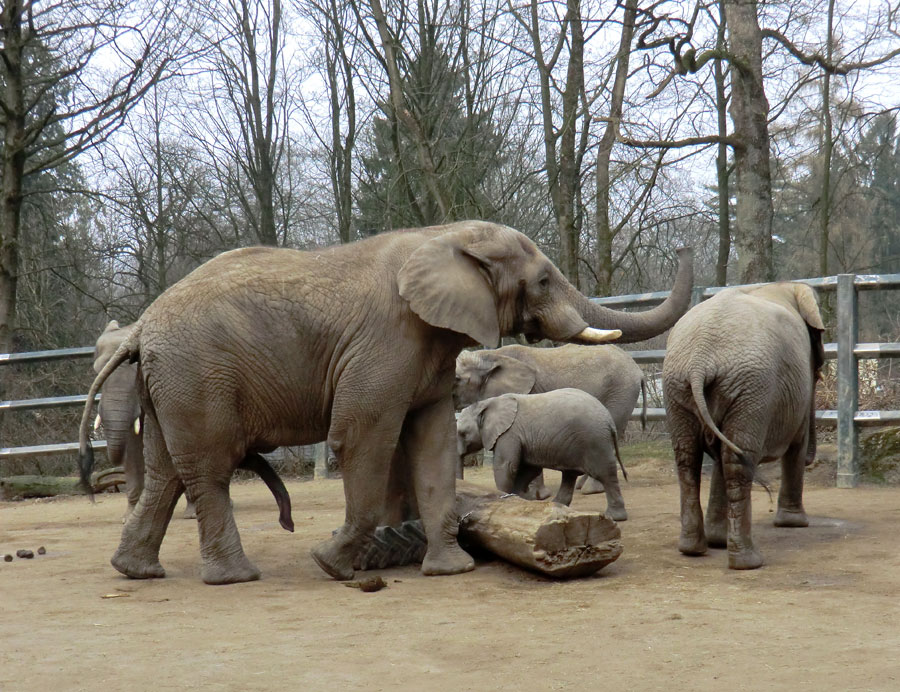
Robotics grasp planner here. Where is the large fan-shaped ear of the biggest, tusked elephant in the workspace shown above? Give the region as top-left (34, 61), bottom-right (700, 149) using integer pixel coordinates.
top-left (397, 227), bottom-right (508, 347)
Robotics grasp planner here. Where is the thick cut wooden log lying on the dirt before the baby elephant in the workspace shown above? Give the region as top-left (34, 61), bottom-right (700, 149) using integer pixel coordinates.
top-left (456, 481), bottom-right (622, 579)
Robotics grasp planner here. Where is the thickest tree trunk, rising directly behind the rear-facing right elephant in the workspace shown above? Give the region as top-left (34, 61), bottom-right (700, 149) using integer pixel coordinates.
top-left (722, 0), bottom-right (775, 283)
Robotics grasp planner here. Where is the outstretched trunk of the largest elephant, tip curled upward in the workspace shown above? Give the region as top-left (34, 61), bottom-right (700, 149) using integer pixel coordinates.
top-left (569, 248), bottom-right (694, 343)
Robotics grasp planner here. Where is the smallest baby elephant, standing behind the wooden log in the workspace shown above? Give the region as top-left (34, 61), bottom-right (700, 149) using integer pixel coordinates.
top-left (456, 389), bottom-right (628, 521)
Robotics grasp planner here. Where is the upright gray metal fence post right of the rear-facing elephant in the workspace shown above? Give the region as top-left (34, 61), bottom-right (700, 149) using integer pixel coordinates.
top-left (837, 274), bottom-right (859, 488)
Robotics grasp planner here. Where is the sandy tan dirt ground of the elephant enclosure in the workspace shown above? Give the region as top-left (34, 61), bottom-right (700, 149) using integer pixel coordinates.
top-left (0, 454), bottom-right (900, 691)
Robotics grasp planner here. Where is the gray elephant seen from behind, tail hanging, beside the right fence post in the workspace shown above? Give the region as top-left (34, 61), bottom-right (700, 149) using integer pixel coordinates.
top-left (663, 282), bottom-right (825, 569)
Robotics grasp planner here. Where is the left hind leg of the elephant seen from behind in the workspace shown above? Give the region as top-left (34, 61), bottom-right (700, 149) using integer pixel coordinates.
top-left (666, 403), bottom-right (707, 555)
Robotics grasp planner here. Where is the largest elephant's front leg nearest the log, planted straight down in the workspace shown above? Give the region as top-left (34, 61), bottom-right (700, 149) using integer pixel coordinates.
top-left (404, 397), bottom-right (475, 575)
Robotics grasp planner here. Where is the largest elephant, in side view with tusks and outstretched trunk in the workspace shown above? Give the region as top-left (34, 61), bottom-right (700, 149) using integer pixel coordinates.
top-left (80, 221), bottom-right (693, 584)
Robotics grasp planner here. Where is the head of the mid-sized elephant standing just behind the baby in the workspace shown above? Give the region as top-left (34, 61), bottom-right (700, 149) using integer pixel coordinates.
top-left (453, 351), bottom-right (537, 408)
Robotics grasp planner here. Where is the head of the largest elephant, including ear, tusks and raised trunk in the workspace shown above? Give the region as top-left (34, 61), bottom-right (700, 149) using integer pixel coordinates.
top-left (397, 222), bottom-right (693, 347)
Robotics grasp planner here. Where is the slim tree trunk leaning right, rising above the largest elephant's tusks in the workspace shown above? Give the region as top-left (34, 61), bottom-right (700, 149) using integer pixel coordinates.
top-left (595, 0), bottom-right (637, 296)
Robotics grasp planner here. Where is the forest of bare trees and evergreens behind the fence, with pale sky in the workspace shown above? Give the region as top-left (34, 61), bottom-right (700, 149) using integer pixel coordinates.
top-left (0, 0), bottom-right (900, 471)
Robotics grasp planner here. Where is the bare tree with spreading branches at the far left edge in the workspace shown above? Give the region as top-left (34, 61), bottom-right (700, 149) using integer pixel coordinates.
top-left (0, 0), bottom-right (191, 352)
